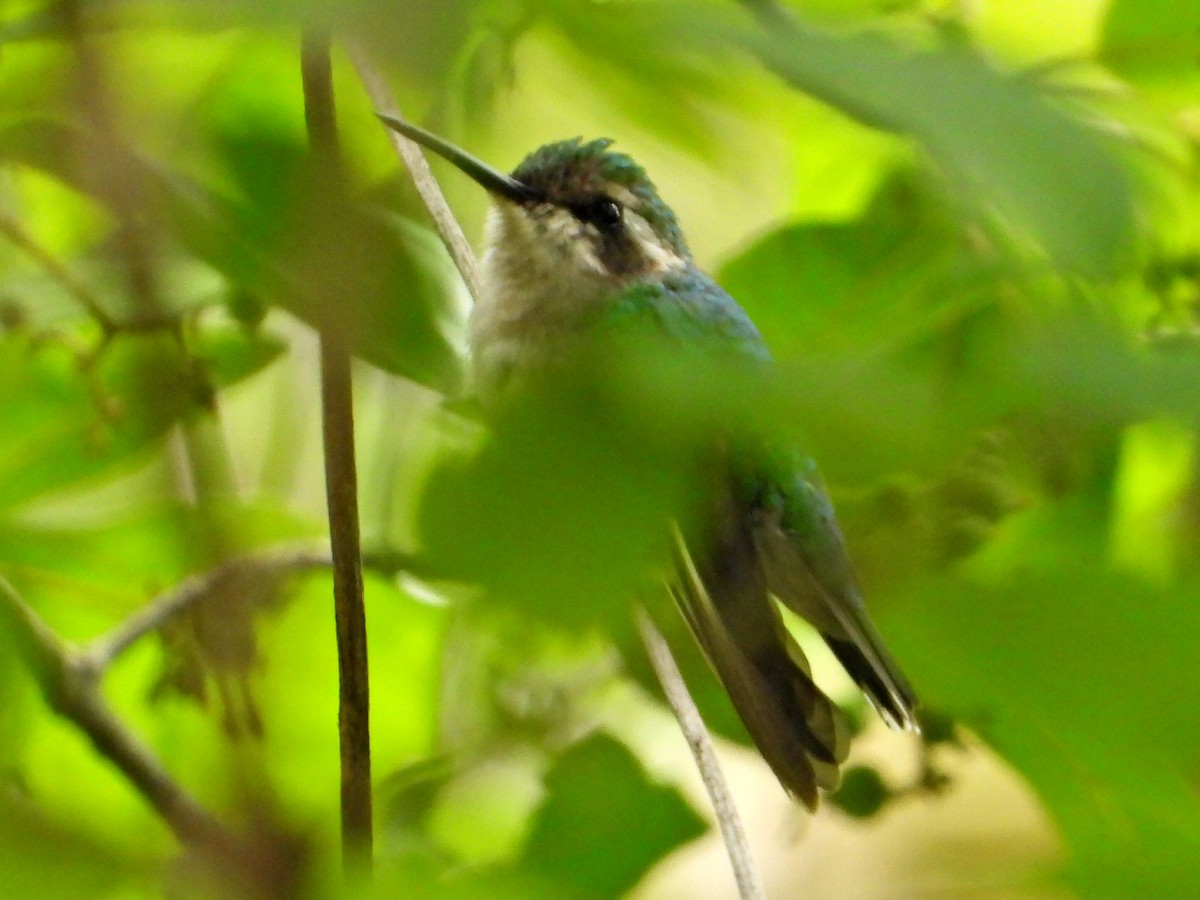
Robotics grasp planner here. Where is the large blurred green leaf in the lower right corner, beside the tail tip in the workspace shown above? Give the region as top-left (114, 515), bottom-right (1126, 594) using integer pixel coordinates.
top-left (889, 549), bottom-right (1200, 896)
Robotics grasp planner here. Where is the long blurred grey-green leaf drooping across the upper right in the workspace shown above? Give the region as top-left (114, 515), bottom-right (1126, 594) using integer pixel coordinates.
top-left (638, 4), bottom-right (1134, 277)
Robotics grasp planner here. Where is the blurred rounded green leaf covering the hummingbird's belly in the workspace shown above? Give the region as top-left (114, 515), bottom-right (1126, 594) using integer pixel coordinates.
top-left (420, 381), bottom-right (697, 631)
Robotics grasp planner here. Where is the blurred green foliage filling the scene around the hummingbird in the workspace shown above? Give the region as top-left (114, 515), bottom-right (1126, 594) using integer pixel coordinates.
top-left (0, 0), bottom-right (1200, 900)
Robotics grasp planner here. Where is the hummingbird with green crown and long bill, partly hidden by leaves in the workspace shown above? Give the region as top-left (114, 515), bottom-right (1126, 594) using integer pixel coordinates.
top-left (379, 115), bottom-right (919, 810)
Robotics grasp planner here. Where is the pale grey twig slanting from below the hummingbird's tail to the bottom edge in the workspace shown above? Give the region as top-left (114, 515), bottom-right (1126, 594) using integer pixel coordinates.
top-left (635, 607), bottom-right (767, 900)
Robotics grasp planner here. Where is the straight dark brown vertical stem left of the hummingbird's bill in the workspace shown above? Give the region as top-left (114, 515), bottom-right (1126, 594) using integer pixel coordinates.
top-left (300, 32), bottom-right (373, 875)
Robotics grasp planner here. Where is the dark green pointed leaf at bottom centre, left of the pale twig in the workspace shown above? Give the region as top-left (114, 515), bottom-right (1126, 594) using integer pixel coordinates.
top-left (522, 734), bottom-right (707, 896)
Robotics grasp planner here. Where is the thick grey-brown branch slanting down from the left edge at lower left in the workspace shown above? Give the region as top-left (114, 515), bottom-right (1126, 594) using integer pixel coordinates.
top-left (0, 577), bottom-right (234, 847)
